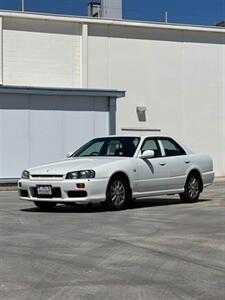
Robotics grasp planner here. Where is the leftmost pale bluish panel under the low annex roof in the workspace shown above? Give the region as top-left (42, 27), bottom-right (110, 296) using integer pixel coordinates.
top-left (0, 95), bottom-right (29, 178)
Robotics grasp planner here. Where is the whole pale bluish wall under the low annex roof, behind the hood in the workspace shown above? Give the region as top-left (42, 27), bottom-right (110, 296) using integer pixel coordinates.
top-left (0, 86), bottom-right (125, 180)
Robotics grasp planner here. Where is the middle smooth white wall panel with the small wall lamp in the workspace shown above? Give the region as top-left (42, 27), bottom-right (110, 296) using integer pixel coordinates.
top-left (110, 28), bottom-right (185, 137)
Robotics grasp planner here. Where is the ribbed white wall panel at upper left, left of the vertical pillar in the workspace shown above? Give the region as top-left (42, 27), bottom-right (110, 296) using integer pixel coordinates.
top-left (3, 18), bottom-right (81, 88)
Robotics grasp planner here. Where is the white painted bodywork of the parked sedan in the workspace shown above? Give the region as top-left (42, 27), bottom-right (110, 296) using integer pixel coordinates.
top-left (18, 136), bottom-right (214, 204)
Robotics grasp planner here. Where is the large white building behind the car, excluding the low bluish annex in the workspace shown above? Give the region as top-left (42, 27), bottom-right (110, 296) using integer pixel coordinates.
top-left (0, 12), bottom-right (225, 177)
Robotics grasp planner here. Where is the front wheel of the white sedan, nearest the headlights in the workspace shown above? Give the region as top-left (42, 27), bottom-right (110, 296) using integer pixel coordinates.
top-left (104, 177), bottom-right (130, 210)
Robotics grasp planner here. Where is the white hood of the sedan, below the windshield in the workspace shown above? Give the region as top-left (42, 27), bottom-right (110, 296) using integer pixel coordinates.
top-left (28, 157), bottom-right (129, 175)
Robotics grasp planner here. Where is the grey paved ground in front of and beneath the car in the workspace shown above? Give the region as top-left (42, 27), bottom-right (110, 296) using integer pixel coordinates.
top-left (0, 182), bottom-right (225, 300)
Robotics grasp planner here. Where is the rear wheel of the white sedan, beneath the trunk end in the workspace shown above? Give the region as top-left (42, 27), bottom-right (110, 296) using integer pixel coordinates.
top-left (180, 174), bottom-right (201, 203)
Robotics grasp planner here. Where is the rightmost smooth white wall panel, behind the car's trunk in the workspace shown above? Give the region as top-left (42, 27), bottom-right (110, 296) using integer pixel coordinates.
top-left (182, 33), bottom-right (224, 174)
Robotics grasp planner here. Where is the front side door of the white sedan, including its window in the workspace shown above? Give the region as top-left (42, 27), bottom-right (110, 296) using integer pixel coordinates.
top-left (137, 138), bottom-right (169, 193)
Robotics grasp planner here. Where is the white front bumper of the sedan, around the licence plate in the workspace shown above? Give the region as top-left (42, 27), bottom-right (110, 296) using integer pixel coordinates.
top-left (18, 178), bottom-right (109, 204)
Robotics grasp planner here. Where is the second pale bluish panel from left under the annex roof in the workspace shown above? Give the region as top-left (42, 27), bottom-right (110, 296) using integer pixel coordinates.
top-left (30, 96), bottom-right (63, 166)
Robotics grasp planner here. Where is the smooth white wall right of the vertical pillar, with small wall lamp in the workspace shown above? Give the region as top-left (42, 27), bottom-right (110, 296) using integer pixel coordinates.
top-left (88, 25), bottom-right (225, 176)
